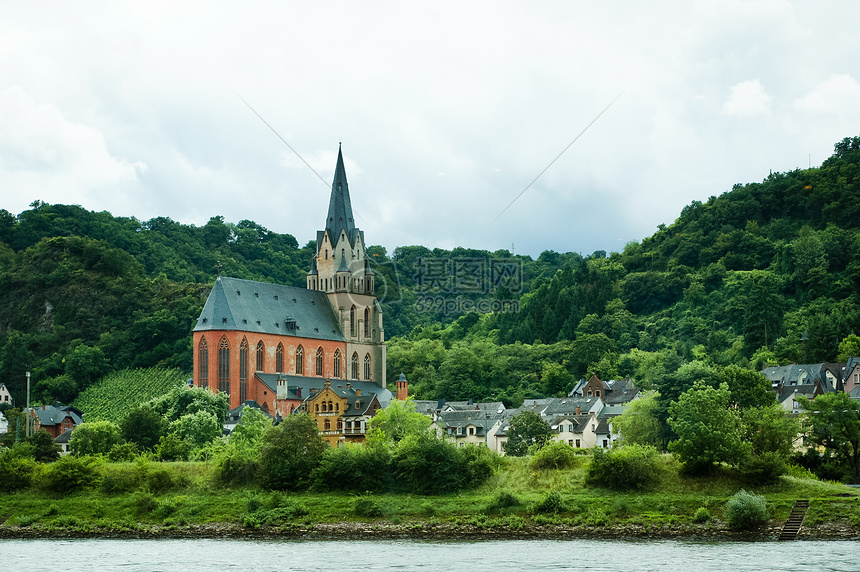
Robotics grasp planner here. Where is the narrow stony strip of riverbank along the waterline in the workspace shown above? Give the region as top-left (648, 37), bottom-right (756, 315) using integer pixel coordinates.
top-left (0, 521), bottom-right (860, 542)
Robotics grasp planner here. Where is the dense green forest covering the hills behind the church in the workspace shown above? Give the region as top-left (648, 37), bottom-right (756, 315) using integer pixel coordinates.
top-left (0, 137), bottom-right (860, 405)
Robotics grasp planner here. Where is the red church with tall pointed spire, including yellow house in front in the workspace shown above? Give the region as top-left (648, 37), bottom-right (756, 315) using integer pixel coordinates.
top-left (193, 148), bottom-right (406, 445)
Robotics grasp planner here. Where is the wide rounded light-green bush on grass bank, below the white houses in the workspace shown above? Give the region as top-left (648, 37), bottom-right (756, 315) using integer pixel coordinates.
top-left (585, 444), bottom-right (660, 490)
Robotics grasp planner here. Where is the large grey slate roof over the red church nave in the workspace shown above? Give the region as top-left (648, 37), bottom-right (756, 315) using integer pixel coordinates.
top-left (194, 276), bottom-right (345, 342)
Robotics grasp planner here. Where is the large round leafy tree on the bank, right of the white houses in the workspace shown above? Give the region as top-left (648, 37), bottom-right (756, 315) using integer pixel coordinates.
top-left (669, 381), bottom-right (750, 473)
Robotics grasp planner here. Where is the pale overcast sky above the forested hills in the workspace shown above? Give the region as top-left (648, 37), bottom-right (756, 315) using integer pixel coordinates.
top-left (0, 0), bottom-right (860, 256)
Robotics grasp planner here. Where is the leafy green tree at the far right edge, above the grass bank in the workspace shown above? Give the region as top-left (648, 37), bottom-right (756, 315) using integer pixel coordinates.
top-left (800, 393), bottom-right (860, 483)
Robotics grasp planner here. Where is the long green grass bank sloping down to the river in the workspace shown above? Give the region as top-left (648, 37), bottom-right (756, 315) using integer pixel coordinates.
top-left (0, 455), bottom-right (860, 538)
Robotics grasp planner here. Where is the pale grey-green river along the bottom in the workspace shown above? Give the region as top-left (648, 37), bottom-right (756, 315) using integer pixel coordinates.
top-left (0, 539), bottom-right (860, 572)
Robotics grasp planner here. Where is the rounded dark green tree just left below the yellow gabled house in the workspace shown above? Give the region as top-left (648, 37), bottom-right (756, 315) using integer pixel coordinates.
top-left (260, 413), bottom-right (328, 490)
